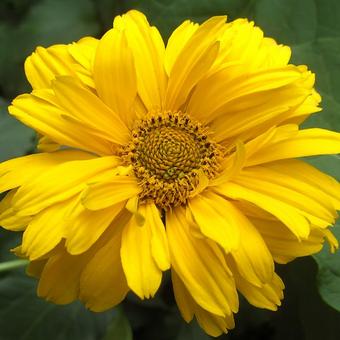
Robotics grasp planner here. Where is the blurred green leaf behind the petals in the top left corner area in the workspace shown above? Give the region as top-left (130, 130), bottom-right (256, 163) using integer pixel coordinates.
top-left (0, 0), bottom-right (100, 99)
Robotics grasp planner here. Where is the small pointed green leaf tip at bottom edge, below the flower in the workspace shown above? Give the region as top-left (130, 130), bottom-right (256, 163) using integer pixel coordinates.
top-left (103, 307), bottom-right (132, 340)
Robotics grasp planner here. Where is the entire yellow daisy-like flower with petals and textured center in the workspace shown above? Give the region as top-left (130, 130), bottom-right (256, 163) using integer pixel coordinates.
top-left (0, 11), bottom-right (340, 336)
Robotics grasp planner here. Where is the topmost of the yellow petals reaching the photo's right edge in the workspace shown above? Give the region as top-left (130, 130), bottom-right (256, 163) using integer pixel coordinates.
top-left (247, 128), bottom-right (340, 166)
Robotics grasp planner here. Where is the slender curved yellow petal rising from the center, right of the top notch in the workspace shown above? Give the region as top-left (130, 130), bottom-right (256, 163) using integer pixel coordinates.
top-left (165, 16), bottom-right (226, 110)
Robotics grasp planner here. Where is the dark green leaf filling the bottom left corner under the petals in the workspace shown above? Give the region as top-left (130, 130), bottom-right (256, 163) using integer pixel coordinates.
top-left (0, 274), bottom-right (116, 340)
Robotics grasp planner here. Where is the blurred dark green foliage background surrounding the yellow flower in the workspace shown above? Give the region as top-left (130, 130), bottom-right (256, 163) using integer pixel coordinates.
top-left (0, 0), bottom-right (340, 340)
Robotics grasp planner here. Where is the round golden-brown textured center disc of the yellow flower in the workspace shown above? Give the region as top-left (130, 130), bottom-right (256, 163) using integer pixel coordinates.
top-left (121, 112), bottom-right (222, 209)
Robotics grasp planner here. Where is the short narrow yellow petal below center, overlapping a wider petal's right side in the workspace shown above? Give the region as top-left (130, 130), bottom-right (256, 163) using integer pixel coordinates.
top-left (138, 203), bottom-right (170, 271)
